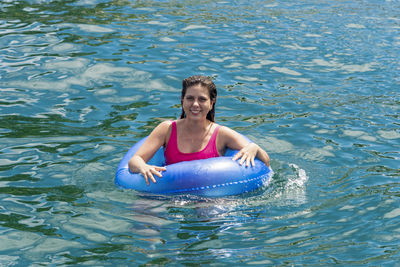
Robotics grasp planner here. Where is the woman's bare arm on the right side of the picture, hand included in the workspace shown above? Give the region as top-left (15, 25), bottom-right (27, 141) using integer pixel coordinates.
top-left (221, 127), bottom-right (270, 167)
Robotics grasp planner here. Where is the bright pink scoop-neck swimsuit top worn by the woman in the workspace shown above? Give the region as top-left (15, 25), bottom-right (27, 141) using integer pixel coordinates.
top-left (164, 121), bottom-right (220, 164)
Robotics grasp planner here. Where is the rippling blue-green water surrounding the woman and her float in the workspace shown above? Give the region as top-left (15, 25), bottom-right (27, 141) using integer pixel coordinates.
top-left (0, 0), bottom-right (400, 266)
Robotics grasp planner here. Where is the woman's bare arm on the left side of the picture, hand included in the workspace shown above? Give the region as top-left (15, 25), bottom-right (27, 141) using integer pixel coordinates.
top-left (128, 121), bottom-right (171, 184)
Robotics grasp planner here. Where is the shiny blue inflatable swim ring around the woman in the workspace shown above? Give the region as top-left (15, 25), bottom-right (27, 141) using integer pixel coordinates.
top-left (115, 137), bottom-right (273, 197)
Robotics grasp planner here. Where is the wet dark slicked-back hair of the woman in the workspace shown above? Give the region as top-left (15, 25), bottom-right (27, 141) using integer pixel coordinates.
top-left (181, 75), bottom-right (217, 122)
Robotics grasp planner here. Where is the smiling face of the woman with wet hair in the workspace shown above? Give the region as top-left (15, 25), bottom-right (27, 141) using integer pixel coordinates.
top-left (182, 84), bottom-right (214, 119)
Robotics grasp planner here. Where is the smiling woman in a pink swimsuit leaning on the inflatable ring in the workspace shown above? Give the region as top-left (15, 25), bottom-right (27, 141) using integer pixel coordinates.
top-left (129, 75), bottom-right (269, 184)
